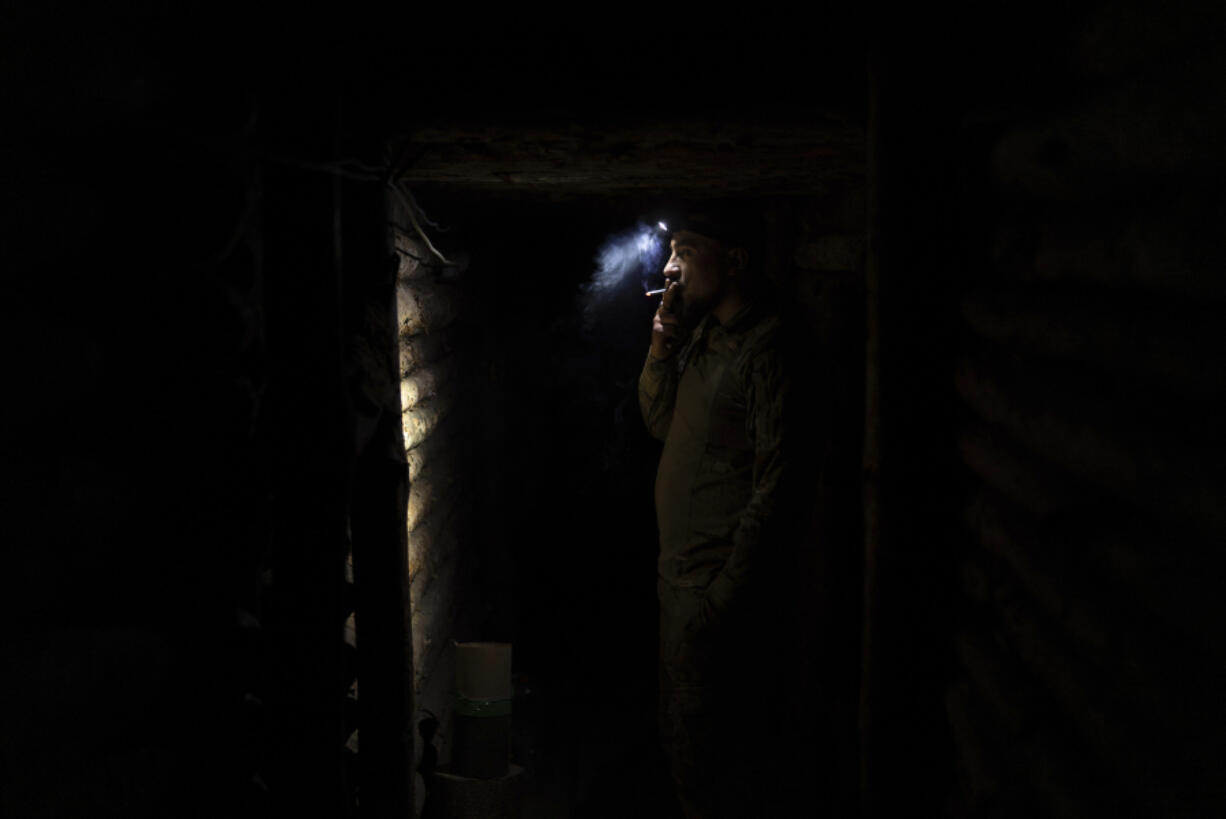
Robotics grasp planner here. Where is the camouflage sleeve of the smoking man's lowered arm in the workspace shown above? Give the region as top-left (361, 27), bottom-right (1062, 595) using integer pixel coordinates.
top-left (706, 340), bottom-right (788, 618)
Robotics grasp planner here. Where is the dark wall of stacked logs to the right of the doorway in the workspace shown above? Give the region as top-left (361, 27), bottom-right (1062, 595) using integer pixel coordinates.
top-left (944, 9), bottom-right (1226, 817)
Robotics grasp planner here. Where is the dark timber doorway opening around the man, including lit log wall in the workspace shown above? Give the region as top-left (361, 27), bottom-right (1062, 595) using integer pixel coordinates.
top-left (392, 164), bottom-right (864, 817)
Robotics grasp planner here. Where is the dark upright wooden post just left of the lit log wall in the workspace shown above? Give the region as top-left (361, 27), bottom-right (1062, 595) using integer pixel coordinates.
top-left (345, 172), bottom-right (413, 819)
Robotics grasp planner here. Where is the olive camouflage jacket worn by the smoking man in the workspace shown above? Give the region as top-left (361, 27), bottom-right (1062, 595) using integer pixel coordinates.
top-left (639, 304), bottom-right (787, 613)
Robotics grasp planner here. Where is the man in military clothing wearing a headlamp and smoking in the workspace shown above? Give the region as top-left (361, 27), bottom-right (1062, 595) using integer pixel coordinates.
top-left (639, 214), bottom-right (786, 817)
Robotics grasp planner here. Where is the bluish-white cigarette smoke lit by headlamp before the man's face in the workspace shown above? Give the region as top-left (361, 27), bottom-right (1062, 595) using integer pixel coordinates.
top-left (580, 222), bottom-right (664, 331)
